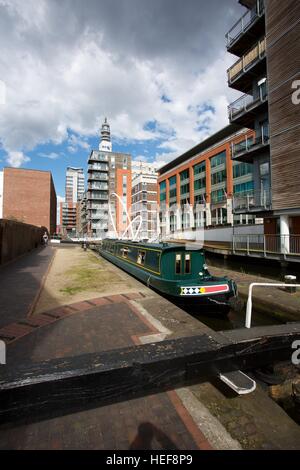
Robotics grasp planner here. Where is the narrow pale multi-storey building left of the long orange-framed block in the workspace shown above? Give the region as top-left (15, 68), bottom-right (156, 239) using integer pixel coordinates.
top-left (131, 173), bottom-right (157, 239)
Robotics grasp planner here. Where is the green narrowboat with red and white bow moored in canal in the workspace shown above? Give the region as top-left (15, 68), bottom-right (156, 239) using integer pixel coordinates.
top-left (99, 239), bottom-right (237, 311)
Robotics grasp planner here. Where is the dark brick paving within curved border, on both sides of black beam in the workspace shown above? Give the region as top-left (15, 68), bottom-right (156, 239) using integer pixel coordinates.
top-left (0, 293), bottom-right (212, 450)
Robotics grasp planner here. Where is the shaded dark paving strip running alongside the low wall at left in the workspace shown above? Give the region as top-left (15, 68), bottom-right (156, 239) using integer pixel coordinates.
top-left (0, 246), bottom-right (55, 327)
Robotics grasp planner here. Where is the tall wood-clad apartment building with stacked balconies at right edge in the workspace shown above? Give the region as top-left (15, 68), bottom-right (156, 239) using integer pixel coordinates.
top-left (226, 0), bottom-right (300, 254)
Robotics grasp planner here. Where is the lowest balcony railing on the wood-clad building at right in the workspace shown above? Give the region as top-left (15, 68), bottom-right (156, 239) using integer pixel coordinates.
top-left (233, 189), bottom-right (272, 212)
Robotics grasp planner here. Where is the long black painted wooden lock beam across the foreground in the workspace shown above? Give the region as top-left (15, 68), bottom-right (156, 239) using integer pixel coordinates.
top-left (0, 323), bottom-right (300, 424)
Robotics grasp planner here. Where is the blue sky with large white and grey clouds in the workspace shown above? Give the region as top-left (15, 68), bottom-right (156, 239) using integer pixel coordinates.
top-left (0, 0), bottom-right (244, 201)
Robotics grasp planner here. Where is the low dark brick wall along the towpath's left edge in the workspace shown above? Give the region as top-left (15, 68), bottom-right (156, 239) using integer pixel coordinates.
top-left (0, 219), bottom-right (45, 265)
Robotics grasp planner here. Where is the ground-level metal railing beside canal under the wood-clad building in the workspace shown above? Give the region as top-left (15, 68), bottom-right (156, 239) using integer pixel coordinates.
top-left (233, 234), bottom-right (300, 257)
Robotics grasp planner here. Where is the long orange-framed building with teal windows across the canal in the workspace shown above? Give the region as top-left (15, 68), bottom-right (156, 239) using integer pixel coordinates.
top-left (158, 124), bottom-right (256, 234)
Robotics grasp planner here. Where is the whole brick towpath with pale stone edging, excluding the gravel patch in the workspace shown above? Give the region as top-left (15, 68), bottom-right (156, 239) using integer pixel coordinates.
top-left (0, 248), bottom-right (300, 450)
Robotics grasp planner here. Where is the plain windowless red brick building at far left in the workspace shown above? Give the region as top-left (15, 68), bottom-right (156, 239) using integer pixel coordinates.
top-left (2, 168), bottom-right (56, 234)
